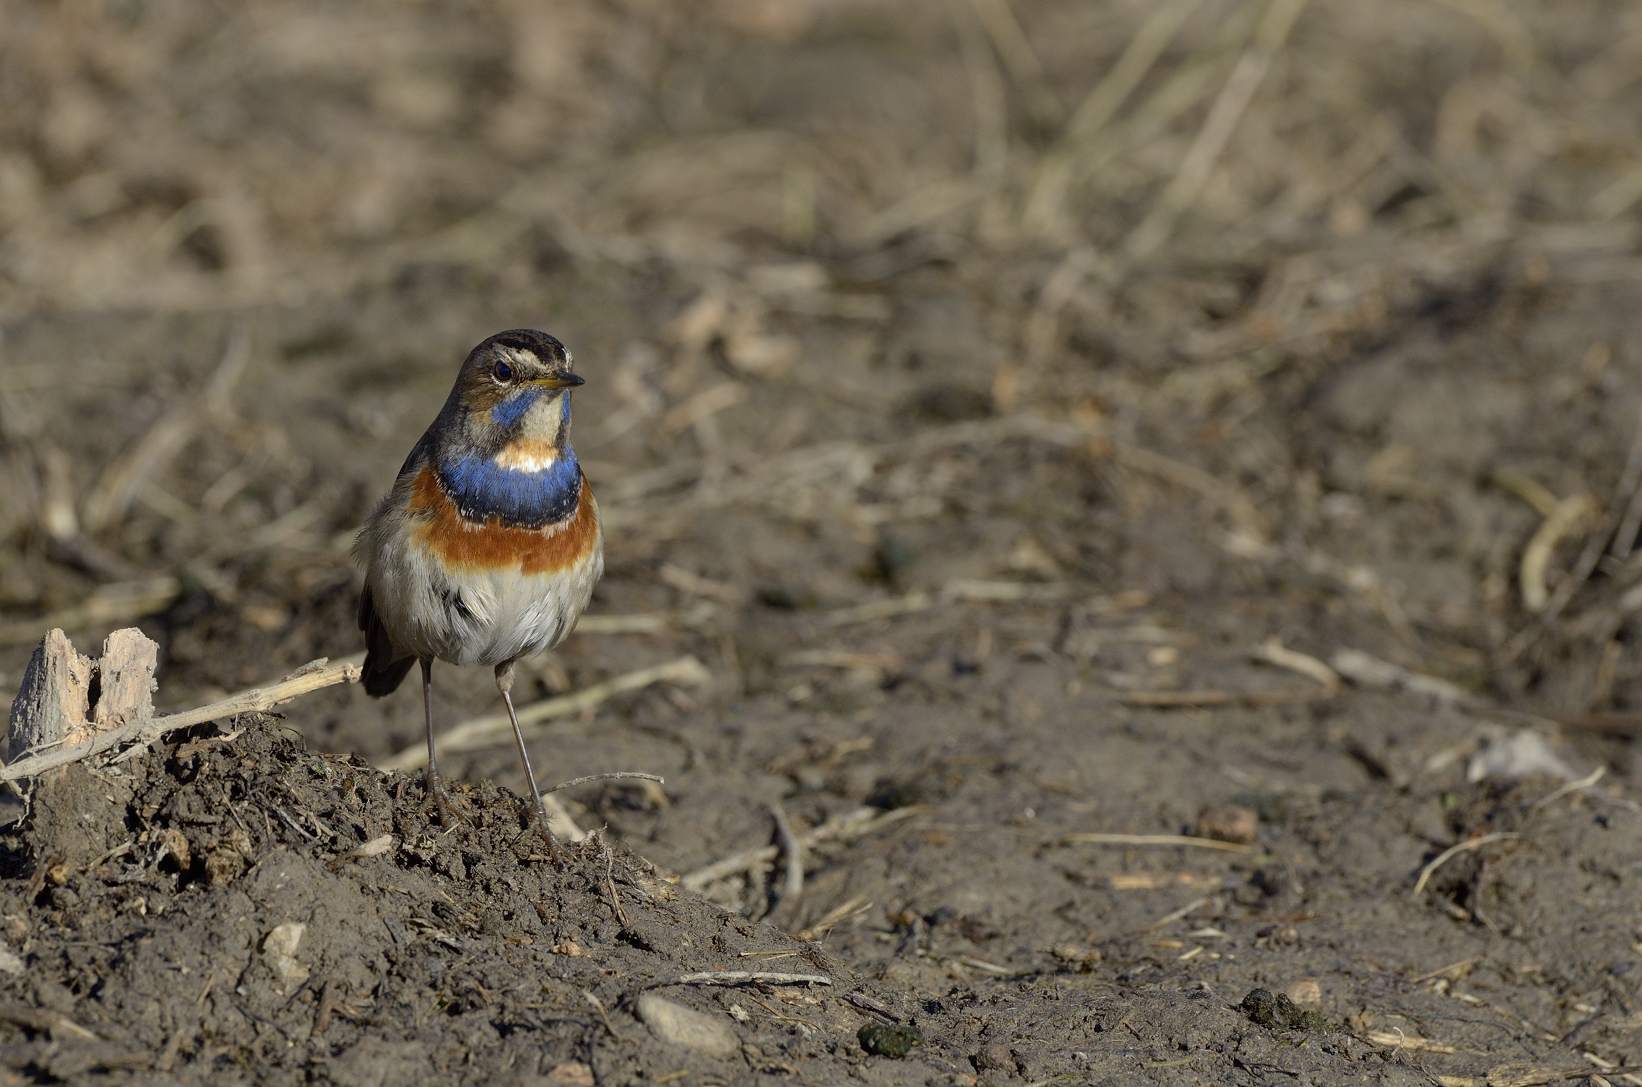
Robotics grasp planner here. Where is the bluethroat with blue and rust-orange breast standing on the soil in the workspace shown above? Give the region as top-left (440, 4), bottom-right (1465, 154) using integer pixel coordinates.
top-left (355, 328), bottom-right (604, 842)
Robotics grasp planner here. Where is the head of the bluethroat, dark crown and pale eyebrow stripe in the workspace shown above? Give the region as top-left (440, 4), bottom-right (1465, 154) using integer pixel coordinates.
top-left (445, 328), bottom-right (581, 461)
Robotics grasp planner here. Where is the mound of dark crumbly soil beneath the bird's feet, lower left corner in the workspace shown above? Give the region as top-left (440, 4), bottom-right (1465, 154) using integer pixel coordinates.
top-left (0, 718), bottom-right (899, 1084)
